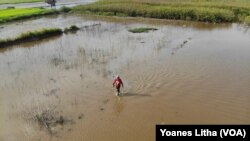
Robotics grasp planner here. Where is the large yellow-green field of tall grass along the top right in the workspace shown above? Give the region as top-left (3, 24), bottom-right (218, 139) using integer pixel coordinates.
top-left (73, 0), bottom-right (250, 23)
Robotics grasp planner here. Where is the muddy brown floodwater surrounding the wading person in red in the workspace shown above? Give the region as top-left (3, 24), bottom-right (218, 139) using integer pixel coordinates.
top-left (0, 15), bottom-right (250, 141)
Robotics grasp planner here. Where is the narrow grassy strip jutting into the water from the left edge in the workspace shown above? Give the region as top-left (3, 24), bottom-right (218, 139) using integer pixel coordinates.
top-left (0, 28), bottom-right (63, 48)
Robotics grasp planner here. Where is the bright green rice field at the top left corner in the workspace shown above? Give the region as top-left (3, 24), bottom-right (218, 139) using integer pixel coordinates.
top-left (0, 8), bottom-right (64, 24)
